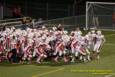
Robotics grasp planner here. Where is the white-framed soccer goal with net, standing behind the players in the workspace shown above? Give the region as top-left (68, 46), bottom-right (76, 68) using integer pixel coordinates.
top-left (85, 1), bottom-right (115, 29)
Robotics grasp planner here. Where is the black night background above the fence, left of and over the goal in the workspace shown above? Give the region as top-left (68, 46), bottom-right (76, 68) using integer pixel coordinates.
top-left (0, 0), bottom-right (115, 19)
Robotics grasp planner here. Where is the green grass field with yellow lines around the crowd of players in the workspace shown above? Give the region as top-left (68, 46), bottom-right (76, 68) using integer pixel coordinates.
top-left (0, 31), bottom-right (115, 77)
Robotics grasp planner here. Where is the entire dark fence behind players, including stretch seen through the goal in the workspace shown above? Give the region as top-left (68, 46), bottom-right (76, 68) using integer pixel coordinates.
top-left (45, 15), bottom-right (115, 30)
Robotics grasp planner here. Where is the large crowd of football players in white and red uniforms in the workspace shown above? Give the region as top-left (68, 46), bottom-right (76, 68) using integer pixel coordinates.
top-left (0, 25), bottom-right (105, 63)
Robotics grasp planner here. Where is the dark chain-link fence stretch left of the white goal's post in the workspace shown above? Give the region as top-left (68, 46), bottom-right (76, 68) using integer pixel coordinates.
top-left (45, 15), bottom-right (85, 29)
